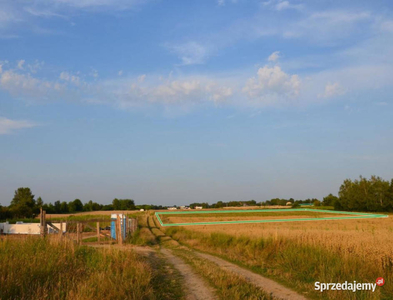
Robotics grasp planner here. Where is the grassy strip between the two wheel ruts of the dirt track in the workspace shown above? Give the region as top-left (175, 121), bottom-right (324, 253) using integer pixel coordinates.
top-left (172, 248), bottom-right (273, 300)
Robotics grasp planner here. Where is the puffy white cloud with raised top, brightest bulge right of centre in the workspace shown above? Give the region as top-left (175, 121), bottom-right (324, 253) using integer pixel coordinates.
top-left (243, 66), bottom-right (301, 104)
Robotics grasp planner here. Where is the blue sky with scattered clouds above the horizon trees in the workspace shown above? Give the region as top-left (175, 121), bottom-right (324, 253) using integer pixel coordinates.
top-left (0, 0), bottom-right (393, 205)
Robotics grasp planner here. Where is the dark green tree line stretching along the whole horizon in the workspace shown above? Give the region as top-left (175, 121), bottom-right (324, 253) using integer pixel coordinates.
top-left (0, 176), bottom-right (393, 220)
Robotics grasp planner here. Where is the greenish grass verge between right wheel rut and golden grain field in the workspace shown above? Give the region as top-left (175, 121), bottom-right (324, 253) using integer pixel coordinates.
top-left (165, 227), bottom-right (393, 300)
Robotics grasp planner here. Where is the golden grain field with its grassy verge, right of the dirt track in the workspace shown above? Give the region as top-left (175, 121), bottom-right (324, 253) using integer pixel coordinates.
top-left (165, 215), bottom-right (393, 299)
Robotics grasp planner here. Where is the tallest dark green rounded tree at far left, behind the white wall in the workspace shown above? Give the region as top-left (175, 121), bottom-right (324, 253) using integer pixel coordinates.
top-left (10, 187), bottom-right (36, 218)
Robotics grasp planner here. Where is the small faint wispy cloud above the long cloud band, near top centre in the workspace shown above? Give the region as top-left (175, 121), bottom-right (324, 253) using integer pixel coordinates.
top-left (167, 41), bottom-right (210, 65)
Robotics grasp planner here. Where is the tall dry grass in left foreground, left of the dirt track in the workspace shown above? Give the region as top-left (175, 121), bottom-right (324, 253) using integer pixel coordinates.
top-left (0, 237), bottom-right (153, 299)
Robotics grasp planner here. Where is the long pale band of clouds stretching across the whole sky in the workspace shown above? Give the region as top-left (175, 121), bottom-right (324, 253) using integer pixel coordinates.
top-left (0, 51), bottom-right (393, 109)
